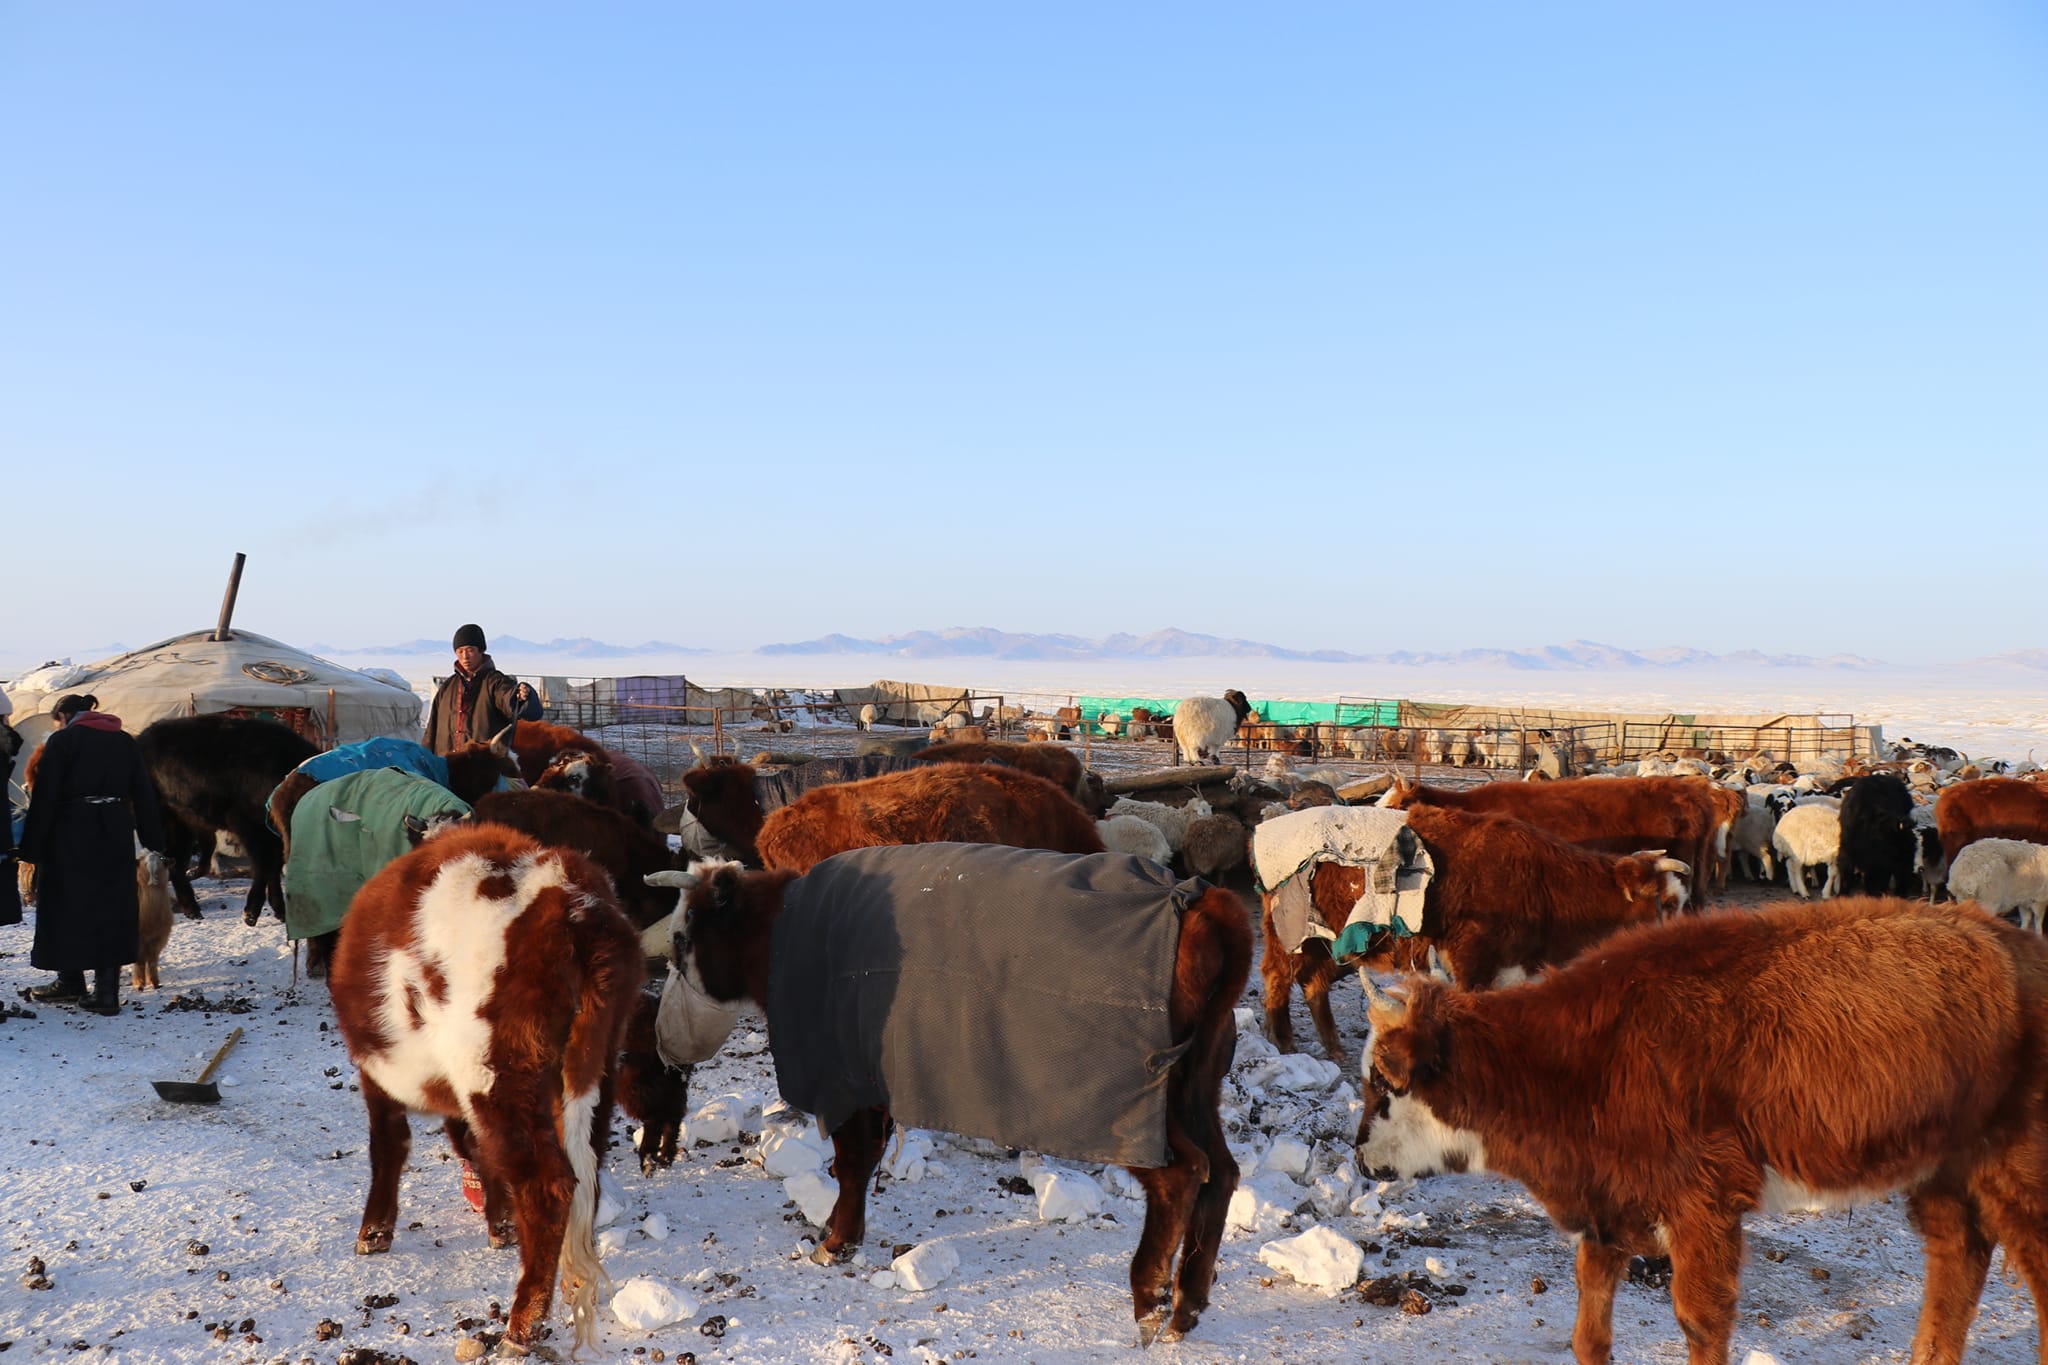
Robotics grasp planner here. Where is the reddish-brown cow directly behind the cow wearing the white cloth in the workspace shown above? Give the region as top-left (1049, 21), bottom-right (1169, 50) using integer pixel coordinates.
top-left (1380, 778), bottom-right (1720, 907)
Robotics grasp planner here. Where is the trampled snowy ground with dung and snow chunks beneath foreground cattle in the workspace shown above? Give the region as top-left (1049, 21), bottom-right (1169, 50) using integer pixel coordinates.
top-left (0, 882), bottom-right (2036, 1363)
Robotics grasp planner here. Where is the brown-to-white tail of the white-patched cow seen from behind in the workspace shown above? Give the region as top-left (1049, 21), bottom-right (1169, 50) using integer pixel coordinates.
top-left (559, 921), bottom-right (641, 1351)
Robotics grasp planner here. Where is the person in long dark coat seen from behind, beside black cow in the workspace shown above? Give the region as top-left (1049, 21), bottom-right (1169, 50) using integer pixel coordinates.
top-left (20, 694), bottom-right (164, 1015)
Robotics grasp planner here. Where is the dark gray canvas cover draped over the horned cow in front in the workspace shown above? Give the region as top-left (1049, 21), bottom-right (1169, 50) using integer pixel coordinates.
top-left (768, 843), bottom-right (1206, 1166)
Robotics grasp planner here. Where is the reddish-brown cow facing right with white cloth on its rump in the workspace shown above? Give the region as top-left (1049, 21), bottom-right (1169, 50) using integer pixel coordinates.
top-left (1260, 806), bottom-right (1690, 1066)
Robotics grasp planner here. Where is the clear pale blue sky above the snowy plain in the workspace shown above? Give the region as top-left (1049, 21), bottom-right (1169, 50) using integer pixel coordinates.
top-left (0, 2), bottom-right (2048, 661)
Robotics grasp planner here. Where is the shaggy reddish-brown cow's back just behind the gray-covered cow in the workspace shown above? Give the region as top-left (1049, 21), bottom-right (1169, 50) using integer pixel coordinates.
top-left (756, 763), bottom-right (1102, 872)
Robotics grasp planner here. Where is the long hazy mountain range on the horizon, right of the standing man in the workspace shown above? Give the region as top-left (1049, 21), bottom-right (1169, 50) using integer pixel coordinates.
top-left (754, 626), bottom-right (1884, 671)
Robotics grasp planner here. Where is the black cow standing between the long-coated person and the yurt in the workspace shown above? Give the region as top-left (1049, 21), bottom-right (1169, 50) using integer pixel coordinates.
top-left (135, 714), bottom-right (319, 925)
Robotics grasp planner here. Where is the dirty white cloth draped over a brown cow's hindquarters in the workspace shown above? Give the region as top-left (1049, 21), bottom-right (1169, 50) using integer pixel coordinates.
top-left (1251, 806), bottom-right (1436, 952)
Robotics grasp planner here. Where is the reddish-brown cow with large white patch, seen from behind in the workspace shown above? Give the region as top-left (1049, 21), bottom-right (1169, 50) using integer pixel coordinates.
top-left (328, 827), bottom-right (641, 1355)
